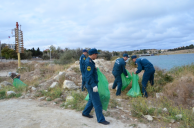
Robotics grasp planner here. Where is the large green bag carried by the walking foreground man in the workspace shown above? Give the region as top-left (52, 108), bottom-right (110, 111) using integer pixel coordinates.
top-left (85, 68), bottom-right (110, 111)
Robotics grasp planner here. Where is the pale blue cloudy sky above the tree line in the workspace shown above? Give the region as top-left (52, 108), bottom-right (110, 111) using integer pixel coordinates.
top-left (0, 0), bottom-right (194, 51)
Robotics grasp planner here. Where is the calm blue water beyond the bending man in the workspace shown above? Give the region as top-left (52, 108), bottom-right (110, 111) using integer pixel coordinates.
top-left (141, 54), bottom-right (194, 70)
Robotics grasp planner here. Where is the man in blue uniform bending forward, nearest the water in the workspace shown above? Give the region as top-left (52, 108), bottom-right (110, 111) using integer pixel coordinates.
top-left (131, 55), bottom-right (155, 98)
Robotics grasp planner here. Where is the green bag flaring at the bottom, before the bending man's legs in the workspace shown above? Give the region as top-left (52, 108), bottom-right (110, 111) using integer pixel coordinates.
top-left (127, 73), bottom-right (142, 97)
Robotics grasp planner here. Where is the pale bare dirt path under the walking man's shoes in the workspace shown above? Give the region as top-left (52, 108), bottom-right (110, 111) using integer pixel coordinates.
top-left (0, 99), bottom-right (150, 128)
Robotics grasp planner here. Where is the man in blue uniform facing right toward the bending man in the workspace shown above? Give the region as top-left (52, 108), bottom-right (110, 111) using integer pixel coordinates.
top-left (112, 54), bottom-right (128, 96)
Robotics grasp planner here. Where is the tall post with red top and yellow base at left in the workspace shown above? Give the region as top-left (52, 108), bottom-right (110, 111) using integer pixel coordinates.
top-left (14, 22), bottom-right (24, 68)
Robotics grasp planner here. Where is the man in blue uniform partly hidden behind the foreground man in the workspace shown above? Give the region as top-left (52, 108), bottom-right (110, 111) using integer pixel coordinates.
top-left (79, 49), bottom-right (88, 91)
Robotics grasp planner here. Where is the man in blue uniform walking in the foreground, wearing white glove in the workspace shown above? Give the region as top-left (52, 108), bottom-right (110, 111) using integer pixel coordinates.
top-left (82, 48), bottom-right (109, 125)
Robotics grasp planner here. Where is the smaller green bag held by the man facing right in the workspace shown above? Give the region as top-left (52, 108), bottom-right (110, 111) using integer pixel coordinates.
top-left (121, 71), bottom-right (132, 91)
